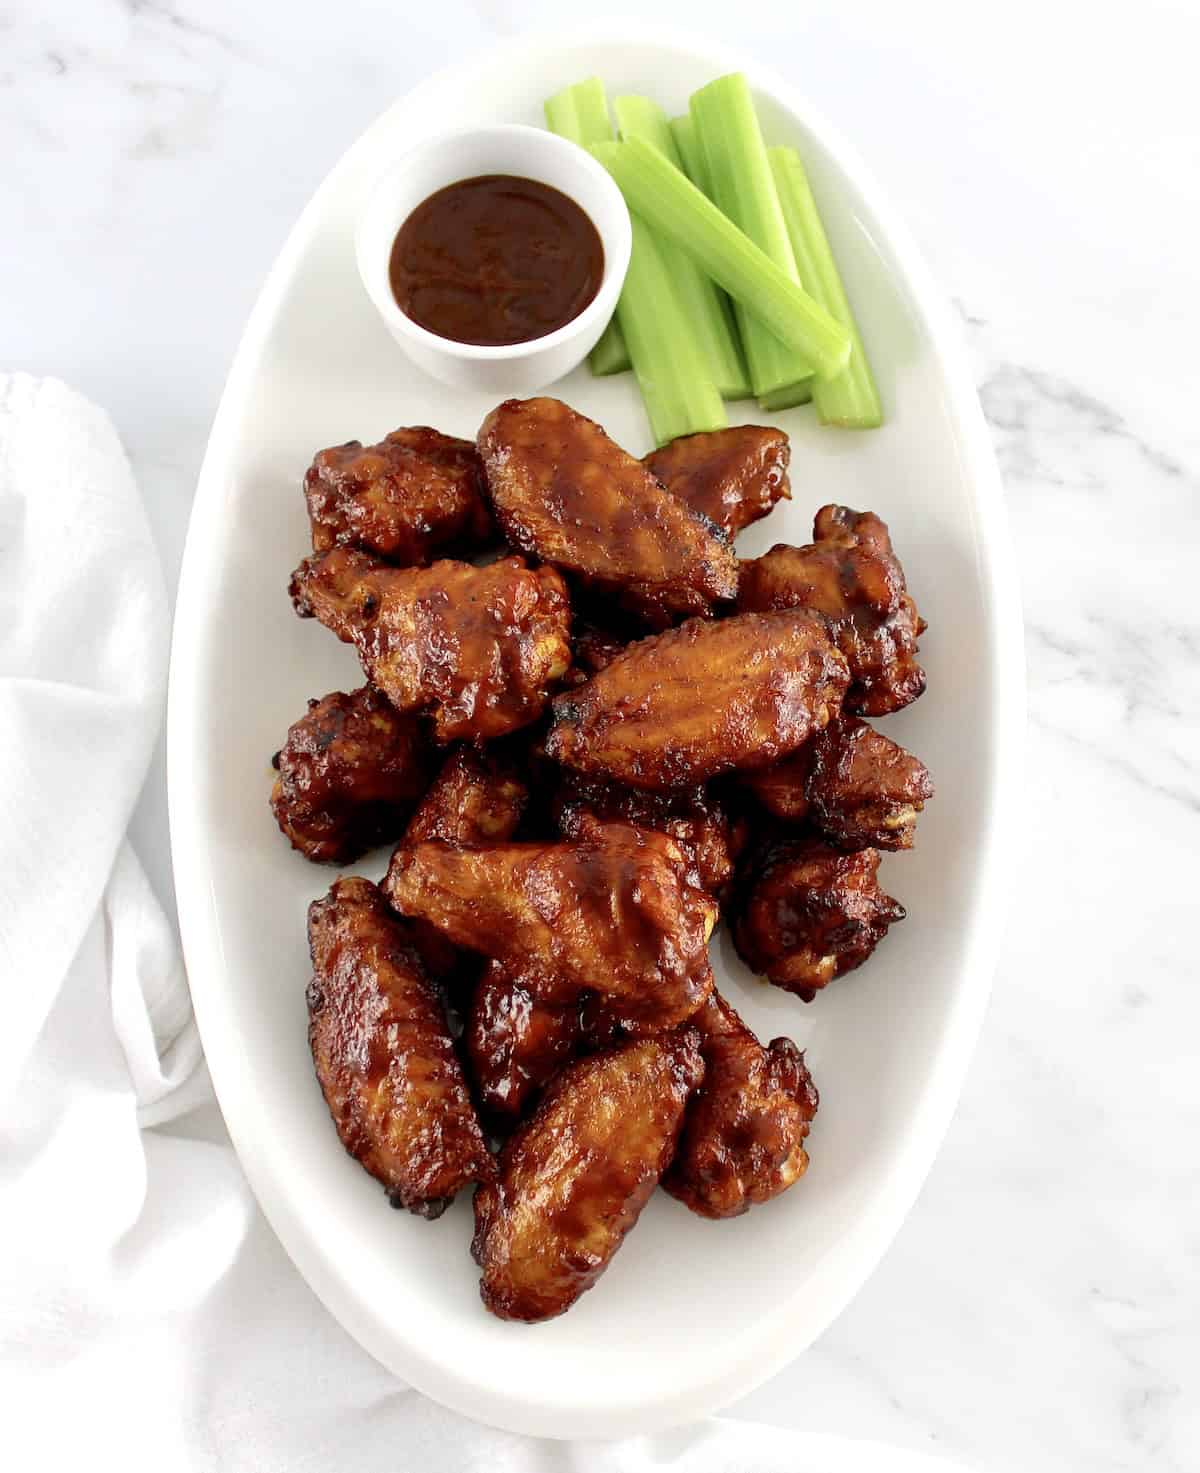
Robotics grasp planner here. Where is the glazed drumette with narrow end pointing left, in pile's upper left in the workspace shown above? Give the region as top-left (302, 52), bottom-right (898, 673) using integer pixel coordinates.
top-left (292, 546), bottom-right (571, 742)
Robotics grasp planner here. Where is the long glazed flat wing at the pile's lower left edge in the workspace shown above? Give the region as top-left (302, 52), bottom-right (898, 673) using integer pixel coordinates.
top-left (308, 878), bottom-right (495, 1217)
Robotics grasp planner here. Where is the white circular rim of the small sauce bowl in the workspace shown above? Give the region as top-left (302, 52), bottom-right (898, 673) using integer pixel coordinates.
top-left (354, 121), bottom-right (633, 364)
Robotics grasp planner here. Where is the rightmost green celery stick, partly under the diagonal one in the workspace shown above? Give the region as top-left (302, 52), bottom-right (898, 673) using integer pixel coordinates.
top-left (767, 149), bottom-right (883, 430)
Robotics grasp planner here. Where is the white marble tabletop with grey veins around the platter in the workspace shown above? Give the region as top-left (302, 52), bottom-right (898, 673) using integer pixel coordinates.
top-left (0, 0), bottom-right (1200, 1473)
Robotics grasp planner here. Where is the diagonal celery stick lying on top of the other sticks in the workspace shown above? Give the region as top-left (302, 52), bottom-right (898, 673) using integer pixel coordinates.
top-left (592, 138), bottom-right (850, 387)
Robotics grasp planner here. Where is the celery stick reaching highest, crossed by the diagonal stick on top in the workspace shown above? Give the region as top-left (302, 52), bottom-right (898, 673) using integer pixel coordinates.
top-left (689, 72), bottom-right (813, 398)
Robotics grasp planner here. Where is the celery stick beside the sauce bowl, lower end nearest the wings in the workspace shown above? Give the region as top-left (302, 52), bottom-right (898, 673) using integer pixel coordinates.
top-left (617, 215), bottom-right (729, 445)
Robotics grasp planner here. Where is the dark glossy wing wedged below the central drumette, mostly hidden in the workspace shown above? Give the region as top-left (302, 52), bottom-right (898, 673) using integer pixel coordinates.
top-left (465, 962), bottom-right (583, 1119)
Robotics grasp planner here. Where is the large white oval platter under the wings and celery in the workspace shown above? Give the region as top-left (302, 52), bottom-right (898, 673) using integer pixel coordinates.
top-left (169, 28), bottom-right (1023, 1438)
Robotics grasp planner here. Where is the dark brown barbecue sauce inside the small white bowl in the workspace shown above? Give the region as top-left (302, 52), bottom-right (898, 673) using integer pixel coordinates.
top-left (389, 174), bottom-right (604, 348)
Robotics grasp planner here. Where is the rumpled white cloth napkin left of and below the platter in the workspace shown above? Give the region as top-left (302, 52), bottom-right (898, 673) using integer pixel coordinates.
top-left (0, 374), bottom-right (977, 1473)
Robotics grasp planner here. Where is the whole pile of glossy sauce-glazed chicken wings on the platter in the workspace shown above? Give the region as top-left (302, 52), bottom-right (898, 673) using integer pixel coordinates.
top-left (271, 398), bottom-right (932, 1321)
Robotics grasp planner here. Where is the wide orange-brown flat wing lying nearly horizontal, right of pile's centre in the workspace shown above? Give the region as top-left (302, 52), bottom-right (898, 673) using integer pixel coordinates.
top-left (546, 610), bottom-right (850, 788)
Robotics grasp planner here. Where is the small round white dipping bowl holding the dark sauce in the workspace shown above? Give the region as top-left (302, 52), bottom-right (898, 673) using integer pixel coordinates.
top-left (355, 124), bottom-right (632, 395)
